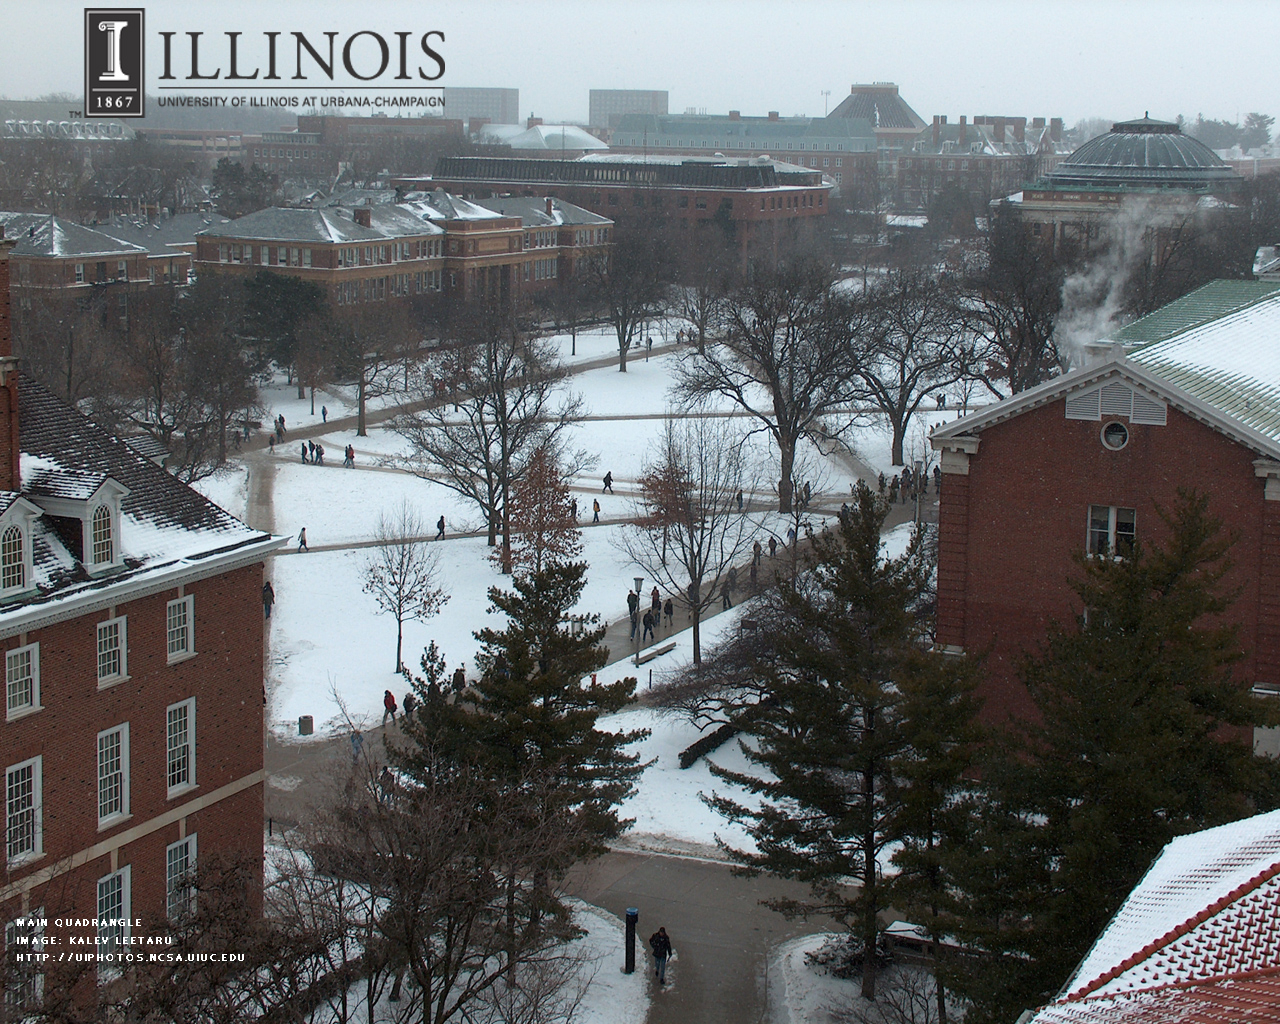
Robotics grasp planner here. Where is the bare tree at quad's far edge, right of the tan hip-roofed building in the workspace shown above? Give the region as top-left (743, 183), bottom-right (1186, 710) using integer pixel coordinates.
top-left (585, 229), bottom-right (669, 374)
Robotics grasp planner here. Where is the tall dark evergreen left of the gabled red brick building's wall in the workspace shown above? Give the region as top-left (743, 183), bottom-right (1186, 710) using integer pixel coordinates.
top-left (710, 485), bottom-right (972, 998)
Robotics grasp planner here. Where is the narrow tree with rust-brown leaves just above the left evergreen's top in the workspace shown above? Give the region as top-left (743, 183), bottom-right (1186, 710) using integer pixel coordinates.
top-left (490, 444), bottom-right (582, 581)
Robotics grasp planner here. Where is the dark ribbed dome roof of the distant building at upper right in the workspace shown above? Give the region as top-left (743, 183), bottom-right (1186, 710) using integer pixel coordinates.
top-left (1048, 118), bottom-right (1240, 189)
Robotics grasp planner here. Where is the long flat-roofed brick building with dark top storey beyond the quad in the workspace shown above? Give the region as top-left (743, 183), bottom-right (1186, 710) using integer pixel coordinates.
top-left (424, 152), bottom-right (832, 266)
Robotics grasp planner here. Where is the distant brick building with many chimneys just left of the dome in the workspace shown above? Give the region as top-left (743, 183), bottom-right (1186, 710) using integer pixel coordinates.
top-left (896, 115), bottom-right (1071, 216)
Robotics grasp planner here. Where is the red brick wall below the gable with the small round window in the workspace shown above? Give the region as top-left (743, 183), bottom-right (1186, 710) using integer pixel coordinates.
top-left (938, 401), bottom-right (1264, 719)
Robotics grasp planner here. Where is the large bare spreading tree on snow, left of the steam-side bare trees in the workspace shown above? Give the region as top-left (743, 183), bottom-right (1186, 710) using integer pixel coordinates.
top-left (676, 259), bottom-right (856, 512)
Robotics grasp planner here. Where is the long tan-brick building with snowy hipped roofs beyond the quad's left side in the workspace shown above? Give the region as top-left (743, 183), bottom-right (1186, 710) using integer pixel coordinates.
top-left (196, 189), bottom-right (612, 306)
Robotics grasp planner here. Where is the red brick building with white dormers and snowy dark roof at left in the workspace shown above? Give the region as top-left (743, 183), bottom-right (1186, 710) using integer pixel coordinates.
top-left (0, 240), bottom-right (284, 1009)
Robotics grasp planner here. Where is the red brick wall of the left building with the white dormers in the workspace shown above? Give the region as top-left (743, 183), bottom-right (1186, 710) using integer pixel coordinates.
top-left (3, 564), bottom-right (262, 916)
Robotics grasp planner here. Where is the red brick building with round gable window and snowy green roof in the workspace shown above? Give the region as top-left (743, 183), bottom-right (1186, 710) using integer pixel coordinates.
top-left (932, 288), bottom-right (1280, 727)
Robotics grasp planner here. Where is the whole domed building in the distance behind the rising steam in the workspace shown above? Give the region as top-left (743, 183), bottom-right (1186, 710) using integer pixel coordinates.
top-left (1001, 116), bottom-right (1243, 251)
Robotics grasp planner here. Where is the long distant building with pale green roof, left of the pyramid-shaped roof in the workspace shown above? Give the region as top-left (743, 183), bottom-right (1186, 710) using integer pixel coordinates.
top-left (609, 110), bottom-right (877, 199)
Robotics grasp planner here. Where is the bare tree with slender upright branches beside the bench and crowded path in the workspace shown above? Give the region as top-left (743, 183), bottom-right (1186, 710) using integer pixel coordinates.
top-left (618, 417), bottom-right (754, 664)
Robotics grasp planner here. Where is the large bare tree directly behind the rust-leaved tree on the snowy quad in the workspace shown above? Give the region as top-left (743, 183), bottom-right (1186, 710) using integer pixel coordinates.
top-left (392, 306), bottom-right (585, 572)
